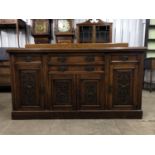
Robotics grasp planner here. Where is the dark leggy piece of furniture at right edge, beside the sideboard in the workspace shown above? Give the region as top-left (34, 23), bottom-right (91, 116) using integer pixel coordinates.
top-left (144, 58), bottom-right (155, 92)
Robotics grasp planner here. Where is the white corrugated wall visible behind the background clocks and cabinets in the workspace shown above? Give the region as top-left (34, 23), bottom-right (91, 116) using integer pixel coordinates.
top-left (0, 19), bottom-right (145, 47)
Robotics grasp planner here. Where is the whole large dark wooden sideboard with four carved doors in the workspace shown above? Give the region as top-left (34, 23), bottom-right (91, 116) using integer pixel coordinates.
top-left (8, 44), bottom-right (145, 119)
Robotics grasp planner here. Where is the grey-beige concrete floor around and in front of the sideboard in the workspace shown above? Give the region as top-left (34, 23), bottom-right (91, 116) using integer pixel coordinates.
top-left (0, 91), bottom-right (155, 135)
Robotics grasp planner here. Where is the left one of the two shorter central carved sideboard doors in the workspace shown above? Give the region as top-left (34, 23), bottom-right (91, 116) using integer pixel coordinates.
top-left (48, 73), bottom-right (76, 111)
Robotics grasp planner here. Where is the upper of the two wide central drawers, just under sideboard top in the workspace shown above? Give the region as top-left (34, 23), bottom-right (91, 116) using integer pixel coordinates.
top-left (48, 55), bottom-right (104, 65)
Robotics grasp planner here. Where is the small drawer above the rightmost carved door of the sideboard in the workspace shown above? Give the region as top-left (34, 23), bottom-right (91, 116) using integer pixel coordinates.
top-left (111, 54), bottom-right (138, 62)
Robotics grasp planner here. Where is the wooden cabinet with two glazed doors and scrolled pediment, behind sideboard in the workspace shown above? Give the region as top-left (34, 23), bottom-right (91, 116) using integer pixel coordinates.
top-left (77, 20), bottom-right (112, 43)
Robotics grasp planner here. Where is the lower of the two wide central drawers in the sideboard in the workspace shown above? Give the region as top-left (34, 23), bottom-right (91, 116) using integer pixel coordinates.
top-left (49, 65), bottom-right (104, 72)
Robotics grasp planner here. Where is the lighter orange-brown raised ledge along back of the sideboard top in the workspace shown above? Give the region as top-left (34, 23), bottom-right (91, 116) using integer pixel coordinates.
top-left (25, 43), bottom-right (128, 48)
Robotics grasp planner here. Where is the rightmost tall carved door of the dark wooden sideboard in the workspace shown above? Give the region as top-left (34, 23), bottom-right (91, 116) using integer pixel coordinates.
top-left (109, 64), bottom-right (138, 109)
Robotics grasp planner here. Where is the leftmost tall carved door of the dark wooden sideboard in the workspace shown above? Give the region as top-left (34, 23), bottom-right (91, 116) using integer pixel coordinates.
top-left (15, 64), bottom-right (44, 110)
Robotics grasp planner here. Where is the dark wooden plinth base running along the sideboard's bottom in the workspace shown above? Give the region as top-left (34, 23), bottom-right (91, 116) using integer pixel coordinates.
top-left (12, 110), bottom-right (143, 119)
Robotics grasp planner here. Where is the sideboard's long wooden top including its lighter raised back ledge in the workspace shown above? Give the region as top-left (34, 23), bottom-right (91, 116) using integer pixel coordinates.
top-left (7, 43), bottom-right (146, 53)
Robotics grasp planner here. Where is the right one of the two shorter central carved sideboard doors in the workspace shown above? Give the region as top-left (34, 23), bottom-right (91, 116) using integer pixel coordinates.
top-left (77, 73), bottom-right (105, 110)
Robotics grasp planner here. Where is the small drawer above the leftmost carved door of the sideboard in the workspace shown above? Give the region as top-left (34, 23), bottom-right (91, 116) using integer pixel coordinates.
top-left (15, 54), bottom-right (41, 63)
